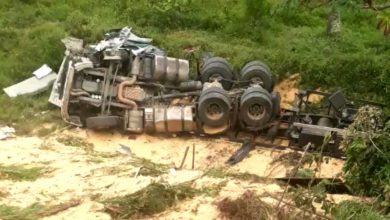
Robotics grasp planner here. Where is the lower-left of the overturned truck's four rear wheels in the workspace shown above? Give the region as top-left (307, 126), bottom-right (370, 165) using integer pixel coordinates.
top-left (198, 87), bottom-right (230, 127)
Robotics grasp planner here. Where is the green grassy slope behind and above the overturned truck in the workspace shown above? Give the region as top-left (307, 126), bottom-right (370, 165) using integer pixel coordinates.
top-left (0, 0), bottom-right (390, 128)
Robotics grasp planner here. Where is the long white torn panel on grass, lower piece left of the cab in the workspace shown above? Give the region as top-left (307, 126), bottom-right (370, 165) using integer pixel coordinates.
top-left (3, 72), bottom-right (57, 98)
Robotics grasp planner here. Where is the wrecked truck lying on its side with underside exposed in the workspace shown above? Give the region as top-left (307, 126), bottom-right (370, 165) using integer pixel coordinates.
top-left (49, 28), bottom-right (384, 151)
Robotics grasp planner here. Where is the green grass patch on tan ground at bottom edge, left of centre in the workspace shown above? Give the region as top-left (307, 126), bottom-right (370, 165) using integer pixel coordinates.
top-left (103, 182), bottom-right (224, 219)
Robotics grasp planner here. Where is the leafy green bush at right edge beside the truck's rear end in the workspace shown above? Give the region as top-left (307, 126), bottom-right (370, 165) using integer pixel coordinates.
top-left (344, 107), bottom-right (390, 209)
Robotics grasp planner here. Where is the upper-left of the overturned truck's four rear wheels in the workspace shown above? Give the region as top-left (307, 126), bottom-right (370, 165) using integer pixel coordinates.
top-left (200, 57), bottom-right (234, 90)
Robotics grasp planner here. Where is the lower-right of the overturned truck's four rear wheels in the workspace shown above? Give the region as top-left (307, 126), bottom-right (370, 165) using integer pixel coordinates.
top-left (240, 87), bottom-right (274, 131)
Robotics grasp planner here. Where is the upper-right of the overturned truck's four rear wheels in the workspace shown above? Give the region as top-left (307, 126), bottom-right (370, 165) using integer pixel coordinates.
top-left (240, 61), bottom-right (274, 92)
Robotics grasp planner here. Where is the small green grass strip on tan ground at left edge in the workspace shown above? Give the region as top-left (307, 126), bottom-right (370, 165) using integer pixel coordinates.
top-left (0, 165), bottom-right (44, 181)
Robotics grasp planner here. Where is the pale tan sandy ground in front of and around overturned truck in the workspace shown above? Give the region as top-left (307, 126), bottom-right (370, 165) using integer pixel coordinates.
top-left (0, 75), bottom-right (350, 219)
